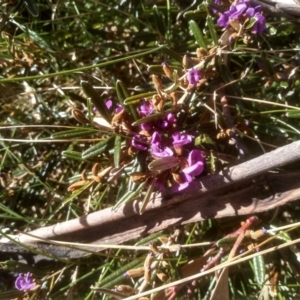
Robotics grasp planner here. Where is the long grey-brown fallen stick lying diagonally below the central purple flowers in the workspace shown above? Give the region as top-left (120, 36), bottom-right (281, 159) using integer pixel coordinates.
top-left (0, 141), bottom-right (300, 255)
